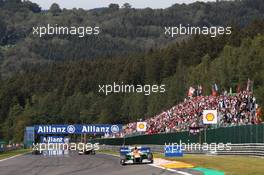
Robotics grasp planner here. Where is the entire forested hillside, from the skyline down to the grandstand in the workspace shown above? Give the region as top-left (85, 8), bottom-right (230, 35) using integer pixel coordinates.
top-left (0, 1), bottom-right (264, 141)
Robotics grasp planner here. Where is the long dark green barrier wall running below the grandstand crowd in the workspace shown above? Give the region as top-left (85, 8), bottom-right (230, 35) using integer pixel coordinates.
top-left (91, 124), bottom-right (264, 145)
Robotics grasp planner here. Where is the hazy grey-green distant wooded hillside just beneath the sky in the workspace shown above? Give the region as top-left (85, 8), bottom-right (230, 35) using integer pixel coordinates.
top-left (0, 0), bottom-right (264, 76)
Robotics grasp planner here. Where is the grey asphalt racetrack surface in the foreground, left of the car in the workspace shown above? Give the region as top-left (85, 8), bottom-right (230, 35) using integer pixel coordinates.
top-left (0, 152), bottom-right (194, 175)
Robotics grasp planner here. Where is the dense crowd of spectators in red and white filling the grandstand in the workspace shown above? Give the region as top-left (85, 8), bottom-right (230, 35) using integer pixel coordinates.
top-left (122, 90), bottom-right (261, 135)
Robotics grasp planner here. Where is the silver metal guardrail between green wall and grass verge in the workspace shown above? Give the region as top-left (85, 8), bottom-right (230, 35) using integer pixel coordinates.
top-left (100, 143), bottom-right (264, 156)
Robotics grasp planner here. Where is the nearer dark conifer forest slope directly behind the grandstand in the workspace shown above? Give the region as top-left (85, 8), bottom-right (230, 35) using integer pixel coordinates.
top-left (0, 21), bottom-right (264, 141)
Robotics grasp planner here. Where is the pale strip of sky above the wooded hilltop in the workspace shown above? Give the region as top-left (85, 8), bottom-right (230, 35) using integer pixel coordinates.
top-left (30, 0), bottom-right (215, 9)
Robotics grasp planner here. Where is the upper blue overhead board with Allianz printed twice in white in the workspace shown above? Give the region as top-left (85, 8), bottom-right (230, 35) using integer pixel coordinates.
top-left (35, 124), bottom-right (122, 134)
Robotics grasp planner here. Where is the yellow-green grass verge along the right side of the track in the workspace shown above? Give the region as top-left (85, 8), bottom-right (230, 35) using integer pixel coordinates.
top-left (98, 150), bottom-right (264, 175)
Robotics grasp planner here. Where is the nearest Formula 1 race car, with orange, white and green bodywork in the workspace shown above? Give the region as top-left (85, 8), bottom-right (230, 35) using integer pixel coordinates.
top-left (120, 147), bottom-right (153, 165)
